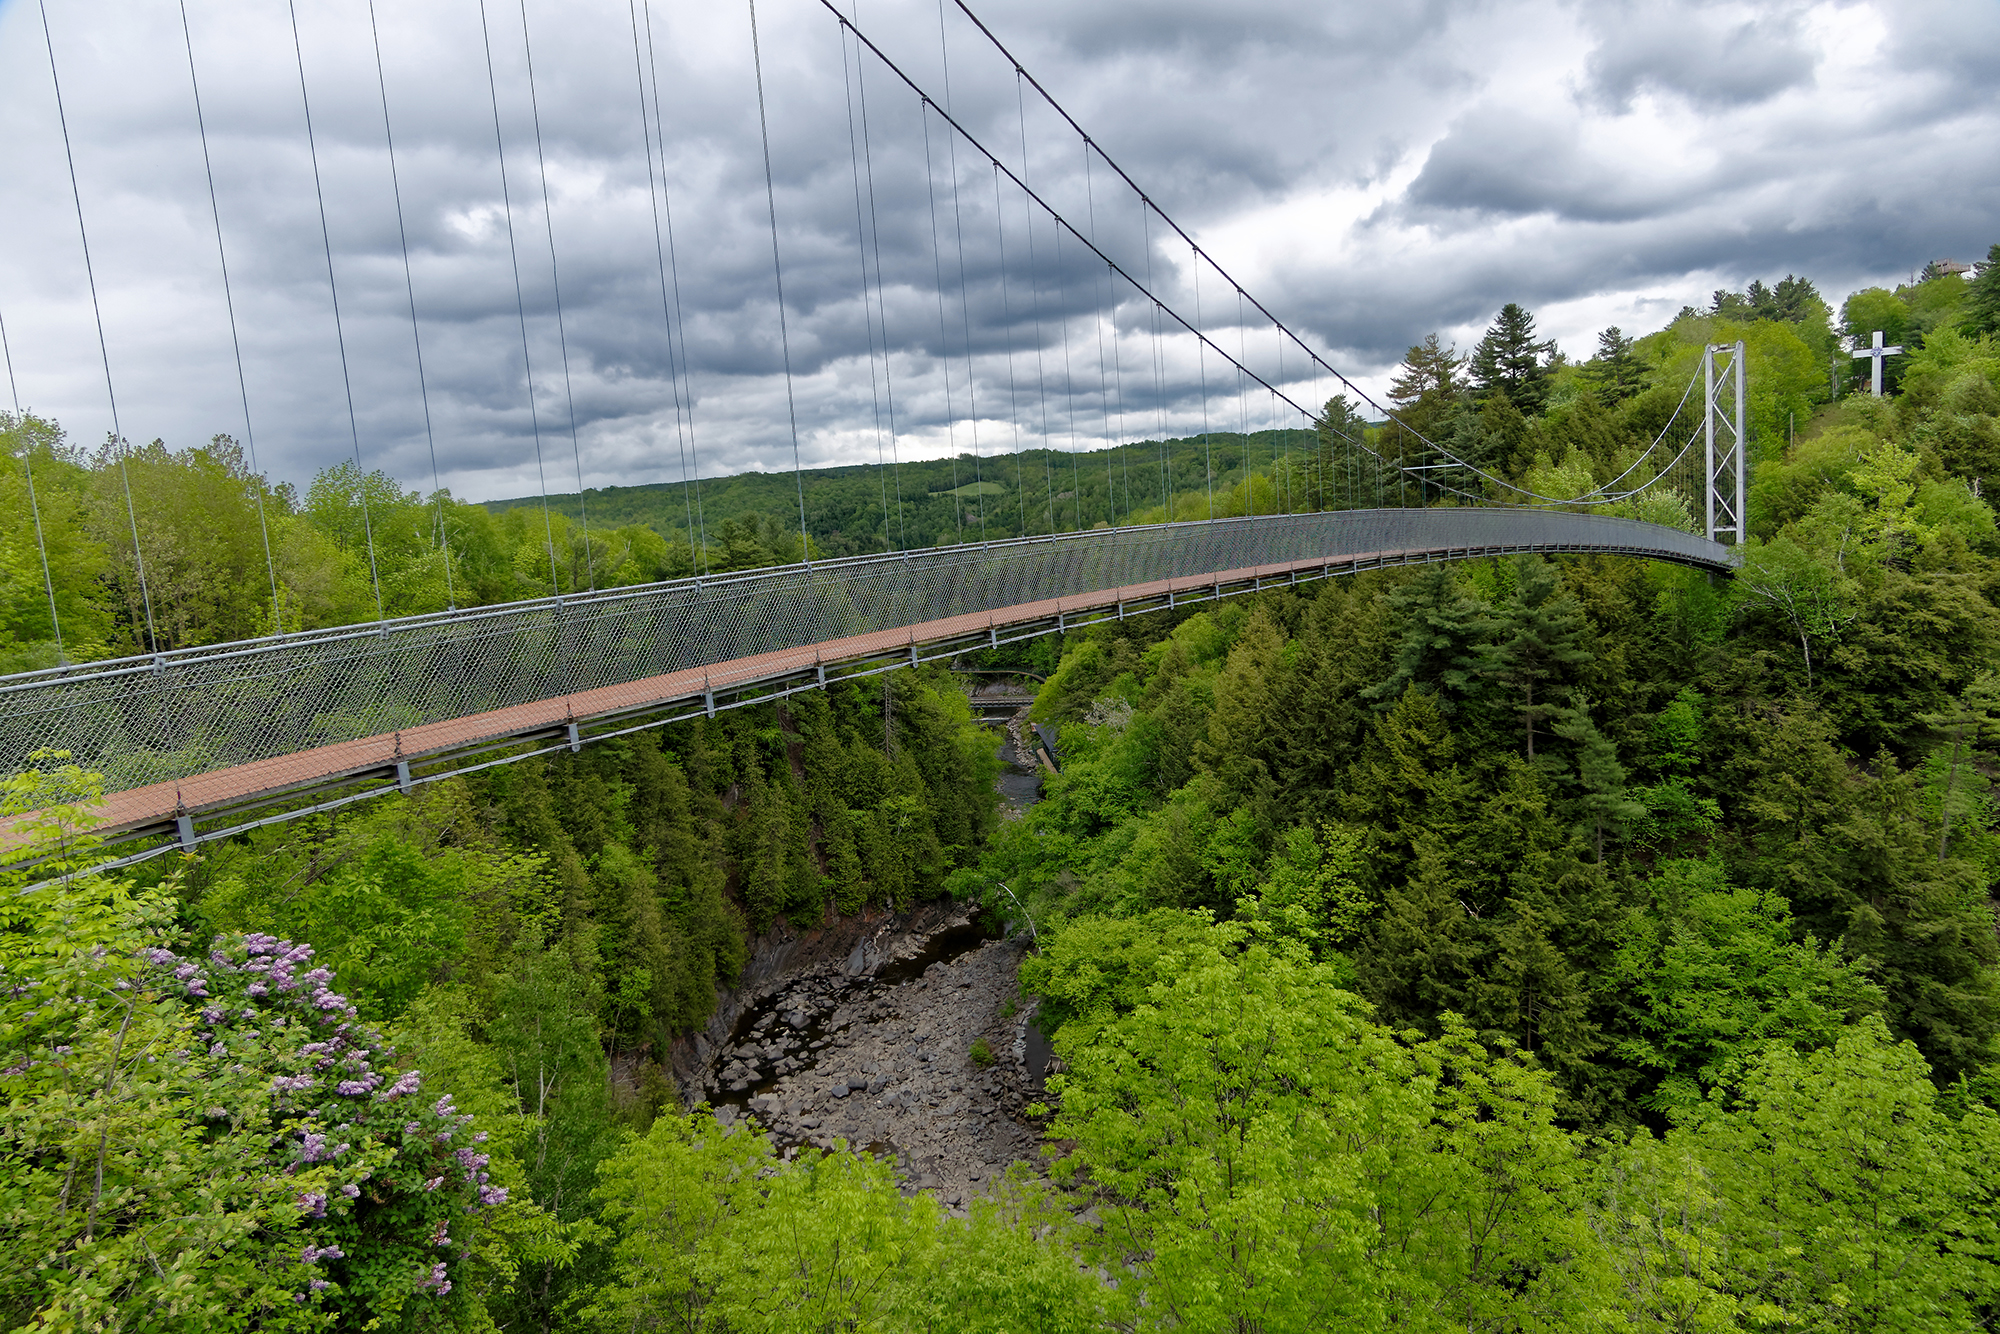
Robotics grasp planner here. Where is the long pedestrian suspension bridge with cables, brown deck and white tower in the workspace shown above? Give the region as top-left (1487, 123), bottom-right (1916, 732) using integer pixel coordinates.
top-left (0, 0), bottom-right (1746, 862)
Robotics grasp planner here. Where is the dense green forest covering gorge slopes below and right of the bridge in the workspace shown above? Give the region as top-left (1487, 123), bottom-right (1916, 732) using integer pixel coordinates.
top-left (0, 246), bottom-right (2000, 1332)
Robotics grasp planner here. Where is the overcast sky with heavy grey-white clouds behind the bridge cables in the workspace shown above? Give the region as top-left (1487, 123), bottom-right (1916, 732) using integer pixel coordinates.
top-left (0, 0), bottom-right (2000, 498)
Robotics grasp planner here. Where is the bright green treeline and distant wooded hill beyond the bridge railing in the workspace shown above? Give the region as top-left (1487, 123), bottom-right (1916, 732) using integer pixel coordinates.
top-left (0, 412), bottom-right (1312, 674)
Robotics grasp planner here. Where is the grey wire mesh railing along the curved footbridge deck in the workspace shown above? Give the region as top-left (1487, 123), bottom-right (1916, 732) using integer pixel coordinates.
top-left (0, 508), bottom-right (1728, 792)
